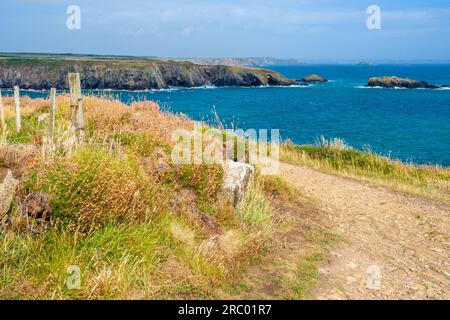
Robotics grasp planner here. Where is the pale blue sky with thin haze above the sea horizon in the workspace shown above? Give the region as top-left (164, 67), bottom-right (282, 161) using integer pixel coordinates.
top-left (0, 0), bottom-right (450, 61)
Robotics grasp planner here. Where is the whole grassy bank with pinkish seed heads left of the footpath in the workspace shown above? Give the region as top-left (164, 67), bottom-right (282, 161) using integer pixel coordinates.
top-left (0, 95), bottom-right (272, 299)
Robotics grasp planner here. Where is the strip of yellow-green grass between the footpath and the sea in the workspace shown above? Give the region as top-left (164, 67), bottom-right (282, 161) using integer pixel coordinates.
top-left (281, 139), bottom-right (450, 202)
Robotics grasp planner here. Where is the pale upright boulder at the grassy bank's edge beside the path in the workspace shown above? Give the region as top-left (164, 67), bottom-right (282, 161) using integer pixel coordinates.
top-left (221, 160), bottom-right (255, 206)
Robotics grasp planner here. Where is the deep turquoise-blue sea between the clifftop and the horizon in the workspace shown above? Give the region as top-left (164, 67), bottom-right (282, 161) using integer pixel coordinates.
top-left (6, 65), bottom-right (450, 166)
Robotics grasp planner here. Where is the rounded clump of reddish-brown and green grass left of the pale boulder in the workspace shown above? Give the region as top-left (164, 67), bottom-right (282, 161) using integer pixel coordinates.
top-left (24, 147), bottom-right (167, 232)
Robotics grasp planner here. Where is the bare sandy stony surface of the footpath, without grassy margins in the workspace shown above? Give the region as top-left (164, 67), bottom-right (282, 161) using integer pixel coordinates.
top-left (280, 164), bottom-right (450, 299)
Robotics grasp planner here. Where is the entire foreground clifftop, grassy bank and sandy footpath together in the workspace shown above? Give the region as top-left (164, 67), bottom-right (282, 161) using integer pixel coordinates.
top-left (0, 93), bottom-right (450, 300)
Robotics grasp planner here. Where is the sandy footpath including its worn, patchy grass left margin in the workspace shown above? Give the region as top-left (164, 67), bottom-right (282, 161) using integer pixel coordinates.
top-left (226, 163), bottom-right (450, 300)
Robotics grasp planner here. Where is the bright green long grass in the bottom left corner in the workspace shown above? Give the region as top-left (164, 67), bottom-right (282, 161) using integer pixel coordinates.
top-left (1, 216), bottom-right (179, 299)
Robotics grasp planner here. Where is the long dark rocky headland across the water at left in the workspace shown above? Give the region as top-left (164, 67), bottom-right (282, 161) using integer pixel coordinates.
top-left (0, 58), bottom-right (295, 90)
